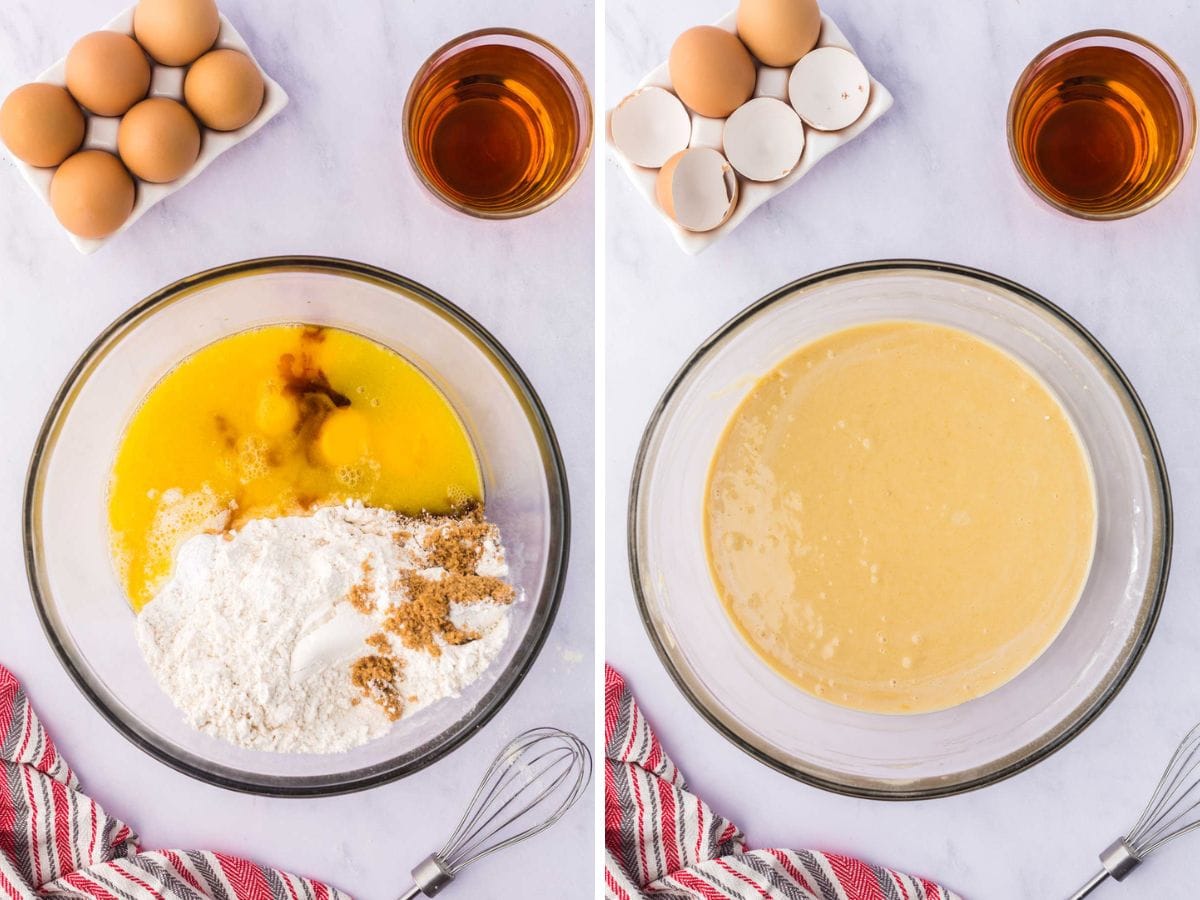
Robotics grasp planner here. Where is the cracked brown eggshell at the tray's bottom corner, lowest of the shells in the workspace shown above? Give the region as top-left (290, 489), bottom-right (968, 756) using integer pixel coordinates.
top-left (654, 146), bottom-right (738, 232)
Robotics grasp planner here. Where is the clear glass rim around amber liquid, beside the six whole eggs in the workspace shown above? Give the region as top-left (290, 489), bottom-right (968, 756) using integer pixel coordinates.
top-left (401, 28), bottom-right (595, 221)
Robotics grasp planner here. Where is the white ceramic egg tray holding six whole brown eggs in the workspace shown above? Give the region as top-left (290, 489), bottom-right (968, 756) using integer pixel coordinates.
top-left (7, 6), bottom-right (288, 253)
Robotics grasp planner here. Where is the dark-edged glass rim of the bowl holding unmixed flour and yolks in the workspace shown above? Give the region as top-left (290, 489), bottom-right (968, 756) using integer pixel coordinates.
top-left (22, 254), bottom-right (571, 797)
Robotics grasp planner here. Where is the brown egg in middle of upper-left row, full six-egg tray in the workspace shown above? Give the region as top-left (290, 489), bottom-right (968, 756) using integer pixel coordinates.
top-left (67, 31), bottom-right (150, 115)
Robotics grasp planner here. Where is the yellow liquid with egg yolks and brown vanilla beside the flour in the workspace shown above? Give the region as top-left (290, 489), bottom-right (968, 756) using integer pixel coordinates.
top-left (108, 325), bottom-right (484, 610)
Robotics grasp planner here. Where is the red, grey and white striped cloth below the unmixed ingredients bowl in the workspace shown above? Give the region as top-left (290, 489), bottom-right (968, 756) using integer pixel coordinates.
top-left (0, 666), bottom-right (349, 900)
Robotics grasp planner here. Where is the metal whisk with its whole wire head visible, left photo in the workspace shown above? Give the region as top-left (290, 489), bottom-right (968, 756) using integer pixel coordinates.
top-left (400, 727), bottom-right (592, 900)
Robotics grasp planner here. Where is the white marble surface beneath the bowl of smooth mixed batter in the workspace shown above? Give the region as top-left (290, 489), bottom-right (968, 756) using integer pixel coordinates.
top-left (605, 0), bottom-right (1200, 900)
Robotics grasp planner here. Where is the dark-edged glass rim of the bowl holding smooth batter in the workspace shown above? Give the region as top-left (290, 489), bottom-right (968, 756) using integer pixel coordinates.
top-left (625, 259), bottom-right (1174, 800)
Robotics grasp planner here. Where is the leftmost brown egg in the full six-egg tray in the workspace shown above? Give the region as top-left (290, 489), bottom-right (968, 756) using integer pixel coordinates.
top-left (0, 82), bottom-right (85, 168)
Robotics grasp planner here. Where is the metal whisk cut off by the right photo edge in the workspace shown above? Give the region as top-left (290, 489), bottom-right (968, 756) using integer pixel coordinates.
top-left (1069, 725), bottom-right (1200, 900)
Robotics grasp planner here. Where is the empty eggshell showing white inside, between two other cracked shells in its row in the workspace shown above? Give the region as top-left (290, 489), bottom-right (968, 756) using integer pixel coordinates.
top-left (721, 97), bottom-right (804, 181)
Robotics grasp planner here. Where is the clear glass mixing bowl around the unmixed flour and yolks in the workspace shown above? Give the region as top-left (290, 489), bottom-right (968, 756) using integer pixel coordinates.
top-left (24, 257), bottom-right (569, 796)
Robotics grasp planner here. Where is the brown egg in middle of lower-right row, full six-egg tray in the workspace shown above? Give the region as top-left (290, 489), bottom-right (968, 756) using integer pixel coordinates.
top-left (116, 97), bottom-right (200, 184)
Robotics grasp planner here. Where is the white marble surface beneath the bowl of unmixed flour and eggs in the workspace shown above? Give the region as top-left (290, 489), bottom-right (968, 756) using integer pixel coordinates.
top-left (0, 0), bottom-right (594, 900)
